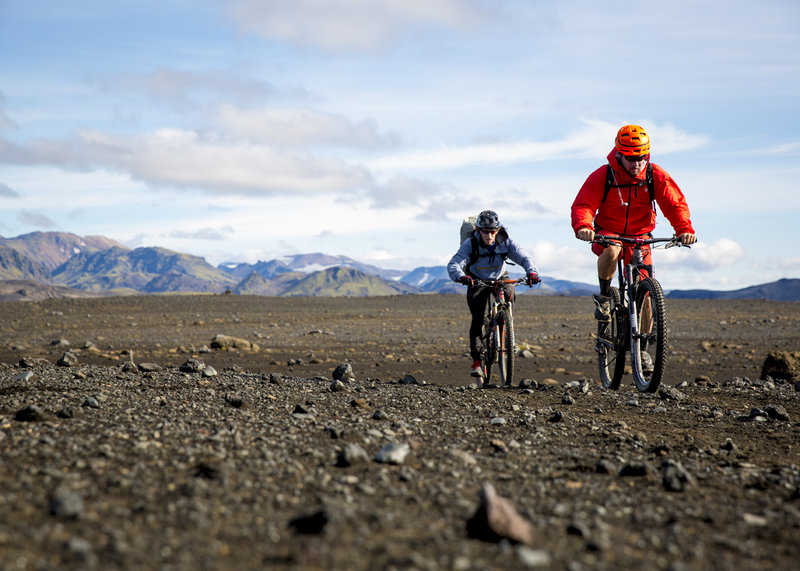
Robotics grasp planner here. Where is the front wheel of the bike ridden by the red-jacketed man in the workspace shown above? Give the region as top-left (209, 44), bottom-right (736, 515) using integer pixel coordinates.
top-left (631, 278), bottom-right (667, 393)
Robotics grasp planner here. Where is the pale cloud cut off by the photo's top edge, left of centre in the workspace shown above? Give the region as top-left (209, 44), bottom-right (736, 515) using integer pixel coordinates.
top-left (230, 0), bottom-right (479, 51)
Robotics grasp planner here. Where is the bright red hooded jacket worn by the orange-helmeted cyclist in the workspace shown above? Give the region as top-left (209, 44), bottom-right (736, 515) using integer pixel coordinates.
top-left (572, 149), bottom-right (694, 236)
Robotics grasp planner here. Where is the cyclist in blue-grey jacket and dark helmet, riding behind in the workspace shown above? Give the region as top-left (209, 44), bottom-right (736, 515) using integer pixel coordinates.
top-left (447, 210), bottom-right (540, 377)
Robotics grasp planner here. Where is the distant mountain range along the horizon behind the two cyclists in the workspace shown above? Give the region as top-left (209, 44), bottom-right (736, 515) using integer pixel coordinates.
top-left (0, 232), bottom-right (800, 301)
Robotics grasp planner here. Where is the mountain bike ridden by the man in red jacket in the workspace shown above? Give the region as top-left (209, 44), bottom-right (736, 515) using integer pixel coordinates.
top-left (593, 236), bottom-right (689, 393)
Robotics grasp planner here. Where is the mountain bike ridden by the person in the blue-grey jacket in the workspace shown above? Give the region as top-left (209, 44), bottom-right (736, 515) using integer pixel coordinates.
top-left (468, 279), bottom-right (525, 387)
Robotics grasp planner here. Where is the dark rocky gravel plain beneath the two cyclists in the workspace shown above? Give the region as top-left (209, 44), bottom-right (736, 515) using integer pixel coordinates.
top-left (0, 295), bottom-right (800, 570)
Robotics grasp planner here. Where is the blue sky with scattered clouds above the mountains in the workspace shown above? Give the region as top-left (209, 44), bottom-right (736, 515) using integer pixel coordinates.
top-left (0, 0), bottom-right (800, 290)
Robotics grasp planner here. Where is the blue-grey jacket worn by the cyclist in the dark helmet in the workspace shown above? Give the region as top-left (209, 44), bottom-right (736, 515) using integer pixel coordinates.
top-left (447, 229), bottom-right (539, 282)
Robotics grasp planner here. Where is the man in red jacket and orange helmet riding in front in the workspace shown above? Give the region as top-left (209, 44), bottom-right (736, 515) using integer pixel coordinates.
top-left (572, 125), bottom-right (697, 322)
